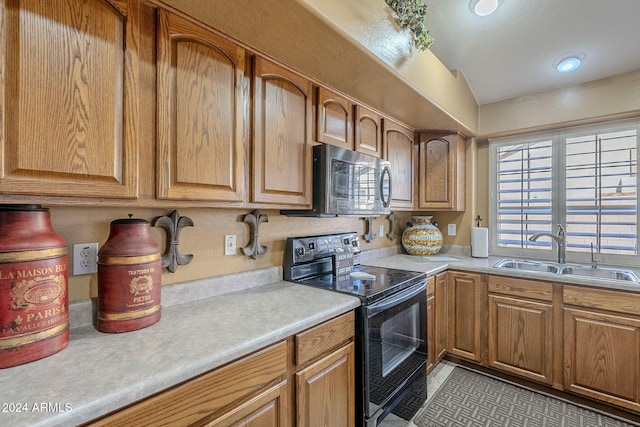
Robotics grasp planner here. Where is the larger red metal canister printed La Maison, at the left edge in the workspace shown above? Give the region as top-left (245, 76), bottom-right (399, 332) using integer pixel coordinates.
top-left (0, 204), bottom-right (69, 368)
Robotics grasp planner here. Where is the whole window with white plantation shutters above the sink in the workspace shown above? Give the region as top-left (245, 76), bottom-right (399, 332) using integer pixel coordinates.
top-left (490, 122), bottom-right (639, 265)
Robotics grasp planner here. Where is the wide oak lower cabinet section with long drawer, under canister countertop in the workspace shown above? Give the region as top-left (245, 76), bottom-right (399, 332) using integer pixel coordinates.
top-left (85, 341), bottom-right (288, 427)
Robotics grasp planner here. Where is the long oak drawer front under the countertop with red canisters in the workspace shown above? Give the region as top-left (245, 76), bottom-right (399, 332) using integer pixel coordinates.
top-left (89, 341), bottom-right (287, 426)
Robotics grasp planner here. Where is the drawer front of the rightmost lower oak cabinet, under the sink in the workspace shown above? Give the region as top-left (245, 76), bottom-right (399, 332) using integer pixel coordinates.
top-left (562, 286), bottom-right (640, 315)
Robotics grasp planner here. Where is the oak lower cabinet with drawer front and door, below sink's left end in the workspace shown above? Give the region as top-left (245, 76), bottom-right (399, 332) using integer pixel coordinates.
top-left (488, 276), bottom-right (554, 384)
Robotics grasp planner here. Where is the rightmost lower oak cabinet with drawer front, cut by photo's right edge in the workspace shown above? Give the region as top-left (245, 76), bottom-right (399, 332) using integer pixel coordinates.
top-left (564, 286), bottom-right (640, 411)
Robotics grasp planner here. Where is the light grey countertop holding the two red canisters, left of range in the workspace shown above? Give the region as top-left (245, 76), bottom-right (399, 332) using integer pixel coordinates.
top-left (0, 281), bottom-right (360, 427)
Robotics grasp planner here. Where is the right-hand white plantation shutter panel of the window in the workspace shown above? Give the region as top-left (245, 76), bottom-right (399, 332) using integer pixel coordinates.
top-left (565, 129), bottom-right (638, 255)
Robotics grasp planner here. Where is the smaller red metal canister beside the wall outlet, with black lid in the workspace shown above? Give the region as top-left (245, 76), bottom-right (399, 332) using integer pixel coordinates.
top-left (96, 216), bottom-right (162, 332)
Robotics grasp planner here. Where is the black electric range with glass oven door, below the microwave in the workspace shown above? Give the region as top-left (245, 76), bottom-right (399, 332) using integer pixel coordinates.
top-left (283, 233), bottom-right (427, 427)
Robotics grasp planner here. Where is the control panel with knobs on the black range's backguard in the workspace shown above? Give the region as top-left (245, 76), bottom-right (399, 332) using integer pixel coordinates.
top-left (283, 232), bottom-right (361, 274)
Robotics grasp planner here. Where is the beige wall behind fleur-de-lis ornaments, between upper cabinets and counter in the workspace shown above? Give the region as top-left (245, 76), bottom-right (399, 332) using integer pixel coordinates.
top-left (50, 206), bottom-right (409, 301)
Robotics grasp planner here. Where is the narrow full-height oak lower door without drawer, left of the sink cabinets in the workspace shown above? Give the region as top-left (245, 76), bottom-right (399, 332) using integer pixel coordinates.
top-left (447, 271), bottom-right (486, 362)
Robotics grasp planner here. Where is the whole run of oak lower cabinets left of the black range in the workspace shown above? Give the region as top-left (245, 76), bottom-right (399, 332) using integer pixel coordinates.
top-left (87, 312), bottom-right (355, 427)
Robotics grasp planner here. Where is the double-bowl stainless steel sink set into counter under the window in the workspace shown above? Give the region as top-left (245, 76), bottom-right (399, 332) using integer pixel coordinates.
top-left (494, 258), bottom-right (640, 284)
